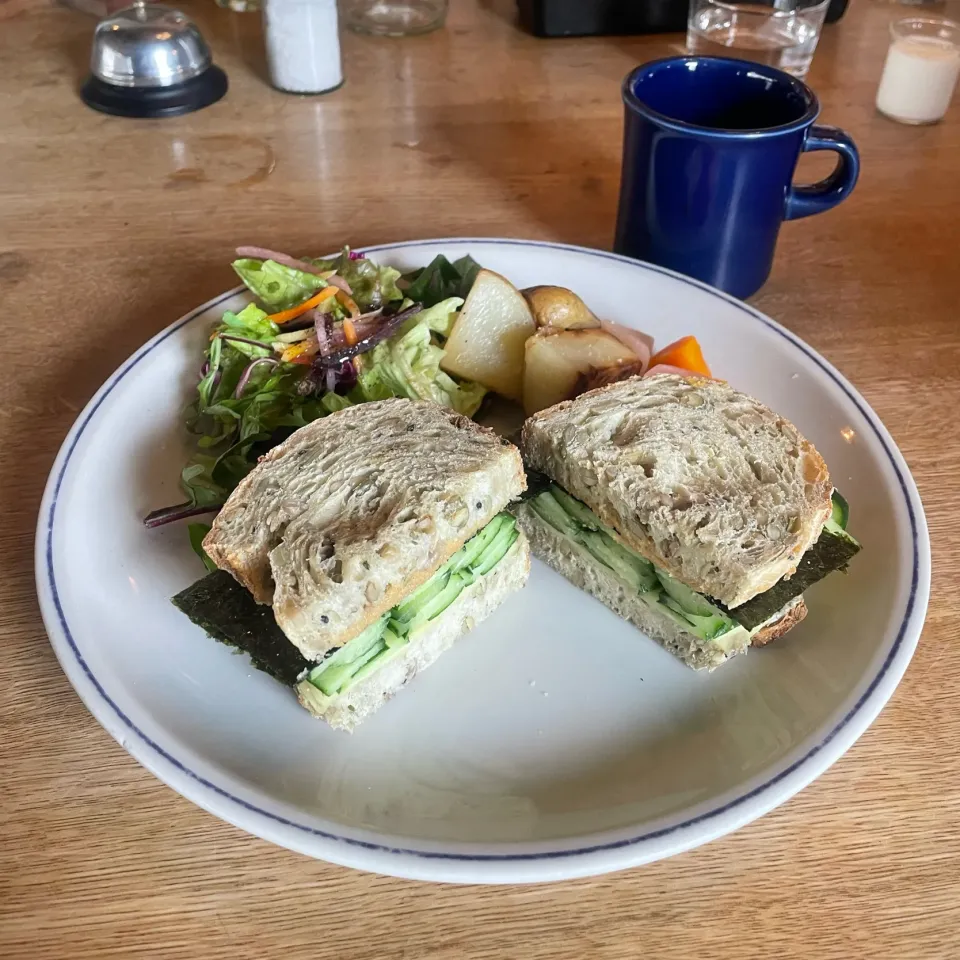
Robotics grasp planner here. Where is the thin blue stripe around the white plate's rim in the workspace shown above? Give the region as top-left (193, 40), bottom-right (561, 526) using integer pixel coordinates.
top-left (45, 237), bottom-right (920, 863)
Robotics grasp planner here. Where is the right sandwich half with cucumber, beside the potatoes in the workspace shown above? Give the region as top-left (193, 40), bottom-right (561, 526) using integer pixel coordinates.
top-left (513, 374), bottom-right (860, 669)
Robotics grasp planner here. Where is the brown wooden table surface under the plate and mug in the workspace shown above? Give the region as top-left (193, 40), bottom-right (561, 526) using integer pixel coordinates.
top-left (0, 0), bottom-right (960, 960)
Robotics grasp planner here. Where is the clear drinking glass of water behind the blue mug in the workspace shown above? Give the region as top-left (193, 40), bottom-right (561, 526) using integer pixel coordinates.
top-left (687, 0), bottom-right (830, 77)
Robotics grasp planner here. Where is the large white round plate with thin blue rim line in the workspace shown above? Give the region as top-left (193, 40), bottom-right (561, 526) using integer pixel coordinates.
top-left (36, 239), bottom-right (930, 883)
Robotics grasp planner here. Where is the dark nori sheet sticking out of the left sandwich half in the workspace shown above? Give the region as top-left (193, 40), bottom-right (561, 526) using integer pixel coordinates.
top-left (173, 570), bottom-right (311, 687)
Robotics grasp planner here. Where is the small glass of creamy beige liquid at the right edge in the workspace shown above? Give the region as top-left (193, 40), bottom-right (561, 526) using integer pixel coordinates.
top-left (877, 17), bottom-right (960, 124)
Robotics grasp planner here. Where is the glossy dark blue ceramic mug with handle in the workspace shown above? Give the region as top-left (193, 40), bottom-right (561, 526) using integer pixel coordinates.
top-left (614, 57), bottom-right (860, 297)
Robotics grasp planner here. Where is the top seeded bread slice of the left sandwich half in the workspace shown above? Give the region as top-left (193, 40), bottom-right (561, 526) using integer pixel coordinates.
top-left (203, 399), bottom-right (526, 660)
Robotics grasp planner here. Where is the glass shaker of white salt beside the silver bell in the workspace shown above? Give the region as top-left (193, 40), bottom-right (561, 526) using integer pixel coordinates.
top-left (263, 0), bottom-right (343, 93)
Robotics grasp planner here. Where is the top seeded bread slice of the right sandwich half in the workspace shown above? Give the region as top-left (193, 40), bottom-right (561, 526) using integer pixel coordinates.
top-left (521, 374), bottom-right (833, 607)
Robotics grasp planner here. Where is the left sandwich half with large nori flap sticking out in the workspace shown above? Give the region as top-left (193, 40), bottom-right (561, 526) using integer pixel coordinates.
top-left (174, 399), bottom-right (530, 730)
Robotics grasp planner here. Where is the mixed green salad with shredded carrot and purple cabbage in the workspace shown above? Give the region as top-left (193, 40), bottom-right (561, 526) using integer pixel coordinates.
top-left (144, 247), bottom-right (487, 559)
